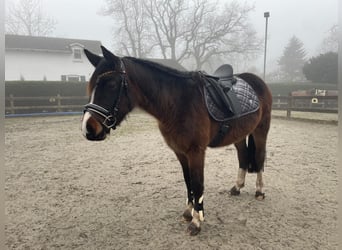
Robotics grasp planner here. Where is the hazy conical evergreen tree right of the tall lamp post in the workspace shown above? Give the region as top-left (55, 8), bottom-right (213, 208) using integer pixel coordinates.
top-left (278, 36), bottom-right (306, 81)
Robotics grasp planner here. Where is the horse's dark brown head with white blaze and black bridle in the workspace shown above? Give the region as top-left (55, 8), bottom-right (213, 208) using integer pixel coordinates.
top-left (82, 46), bottom-right (132, 140)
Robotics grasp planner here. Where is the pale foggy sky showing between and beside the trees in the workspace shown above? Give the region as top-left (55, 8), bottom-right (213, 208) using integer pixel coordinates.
top-left (6, 0), bottom-right (338, 71)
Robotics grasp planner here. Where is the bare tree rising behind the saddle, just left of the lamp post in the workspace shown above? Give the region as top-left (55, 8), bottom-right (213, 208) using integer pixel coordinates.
top-left (190, 1), bottom-right (262, 69)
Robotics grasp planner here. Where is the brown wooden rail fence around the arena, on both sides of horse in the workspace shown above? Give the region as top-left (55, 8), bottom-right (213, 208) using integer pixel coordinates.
top-left (5, 95), bottom-right (338, 117)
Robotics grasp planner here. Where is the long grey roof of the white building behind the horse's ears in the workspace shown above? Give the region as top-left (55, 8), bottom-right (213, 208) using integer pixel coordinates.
top-left (5, 35), bottom-right (101, 54)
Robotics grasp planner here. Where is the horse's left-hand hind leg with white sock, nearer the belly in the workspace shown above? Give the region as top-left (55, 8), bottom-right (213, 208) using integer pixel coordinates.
top-left (230, 139), bottom-right (249, 195)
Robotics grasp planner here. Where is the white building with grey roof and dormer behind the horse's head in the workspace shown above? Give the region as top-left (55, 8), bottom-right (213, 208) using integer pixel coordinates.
top-left (5, 35), bottom-right (101, 81)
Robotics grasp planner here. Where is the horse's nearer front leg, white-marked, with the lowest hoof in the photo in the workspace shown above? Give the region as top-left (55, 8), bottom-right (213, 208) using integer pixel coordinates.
top-left (187, 149), bottom-right (205, 235)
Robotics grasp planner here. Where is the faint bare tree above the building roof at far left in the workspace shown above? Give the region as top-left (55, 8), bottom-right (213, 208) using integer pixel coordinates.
top-left (5, 0), bottom-right (57, 36)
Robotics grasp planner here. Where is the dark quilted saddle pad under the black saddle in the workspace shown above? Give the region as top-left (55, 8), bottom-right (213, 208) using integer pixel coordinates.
top-left (204, 77), bottom-right (259, 122)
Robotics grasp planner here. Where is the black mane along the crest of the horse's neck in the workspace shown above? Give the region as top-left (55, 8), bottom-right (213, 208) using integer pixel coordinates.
top-left (124, 57), bottom-right (193, 78)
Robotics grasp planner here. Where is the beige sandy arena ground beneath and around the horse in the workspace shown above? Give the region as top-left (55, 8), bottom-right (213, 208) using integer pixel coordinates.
top-left (5, 112), bottom-right (338, 250)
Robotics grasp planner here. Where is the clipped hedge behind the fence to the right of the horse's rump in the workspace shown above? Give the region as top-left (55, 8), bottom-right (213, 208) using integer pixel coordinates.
top-left (267, 82), bottom-right (338, 96)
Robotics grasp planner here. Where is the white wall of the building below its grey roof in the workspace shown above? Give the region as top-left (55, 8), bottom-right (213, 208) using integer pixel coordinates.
top-left (5, 50), bottom-right (94, 81)
